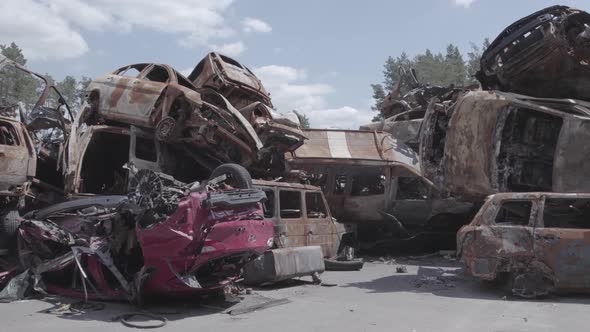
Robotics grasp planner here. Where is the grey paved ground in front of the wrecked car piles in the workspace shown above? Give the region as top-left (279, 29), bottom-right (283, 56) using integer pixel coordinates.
top-left (0, 256), bottom-right (590, 332)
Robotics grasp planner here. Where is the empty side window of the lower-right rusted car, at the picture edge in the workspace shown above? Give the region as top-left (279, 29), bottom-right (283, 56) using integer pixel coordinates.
top-left (543, 198), bottom-right (590, 229)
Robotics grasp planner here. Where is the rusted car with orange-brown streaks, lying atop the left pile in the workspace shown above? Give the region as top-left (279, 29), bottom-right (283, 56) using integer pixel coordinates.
top-left (81, 63), bottom-right (262, 164)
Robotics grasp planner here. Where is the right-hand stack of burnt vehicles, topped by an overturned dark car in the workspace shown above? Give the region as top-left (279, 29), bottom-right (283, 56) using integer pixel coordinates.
top-left (361, 6), bottom-right (590, 296)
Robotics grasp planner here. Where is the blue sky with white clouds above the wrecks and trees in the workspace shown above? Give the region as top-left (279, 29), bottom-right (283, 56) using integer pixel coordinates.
top-left (0, 0), bottom-right (590, 129)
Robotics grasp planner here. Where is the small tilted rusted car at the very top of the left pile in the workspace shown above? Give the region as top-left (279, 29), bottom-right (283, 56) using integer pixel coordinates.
top-left (188, 52), bottom-right (273, 109)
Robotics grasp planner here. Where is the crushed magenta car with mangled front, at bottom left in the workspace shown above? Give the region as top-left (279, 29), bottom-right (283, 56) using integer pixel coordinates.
top-left (4, 165), bottom-right (273, 302)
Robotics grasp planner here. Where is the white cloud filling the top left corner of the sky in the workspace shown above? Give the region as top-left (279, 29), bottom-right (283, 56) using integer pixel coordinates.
top-left (0, 0), bottom-right (89, 59)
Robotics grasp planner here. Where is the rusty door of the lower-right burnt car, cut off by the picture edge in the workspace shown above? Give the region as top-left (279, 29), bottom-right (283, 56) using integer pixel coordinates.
top-left (535, 196), bottom-right (590, 289)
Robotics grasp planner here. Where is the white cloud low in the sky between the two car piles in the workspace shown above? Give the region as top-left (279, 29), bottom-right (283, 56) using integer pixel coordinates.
top-left (253, 65), bottom-right (372, 129)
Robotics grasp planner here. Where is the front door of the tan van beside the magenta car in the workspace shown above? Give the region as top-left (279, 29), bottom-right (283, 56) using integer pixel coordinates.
top-left (305, 191), bottom-right (338, 257)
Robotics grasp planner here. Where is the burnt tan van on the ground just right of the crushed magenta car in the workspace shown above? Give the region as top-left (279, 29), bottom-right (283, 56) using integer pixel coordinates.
top-left (253, 180), bottom-right (354, 258)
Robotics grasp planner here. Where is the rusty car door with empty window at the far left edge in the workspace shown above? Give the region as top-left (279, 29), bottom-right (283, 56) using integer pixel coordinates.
top-left (0, 119), bottom-right (35, 191)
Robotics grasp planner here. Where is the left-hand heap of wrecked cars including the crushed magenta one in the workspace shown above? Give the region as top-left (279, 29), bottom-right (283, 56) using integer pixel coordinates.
top-left (0, 53), bottom-right (362, 303)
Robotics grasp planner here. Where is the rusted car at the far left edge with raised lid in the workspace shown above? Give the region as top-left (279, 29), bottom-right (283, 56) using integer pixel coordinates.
top-left (0, 55), bottom-right (72, 247)
